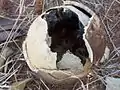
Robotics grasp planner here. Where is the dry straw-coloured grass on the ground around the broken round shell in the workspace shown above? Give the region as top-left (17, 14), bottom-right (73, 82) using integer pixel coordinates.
top-left (0, 0), bottom-right (120, 90)
